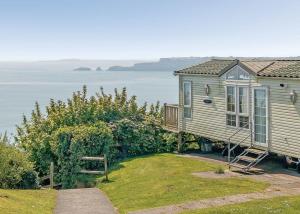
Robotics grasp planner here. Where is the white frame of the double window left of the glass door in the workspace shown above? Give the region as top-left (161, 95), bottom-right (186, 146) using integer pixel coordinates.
top-left (225, 83), bottom-right (250, 130)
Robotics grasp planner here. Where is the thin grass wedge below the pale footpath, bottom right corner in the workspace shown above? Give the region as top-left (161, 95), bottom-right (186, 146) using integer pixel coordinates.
top-left (183, 196), bottom-right (300, 214)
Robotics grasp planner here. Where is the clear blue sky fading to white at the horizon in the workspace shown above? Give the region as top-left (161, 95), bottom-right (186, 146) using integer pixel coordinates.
top-left (0, 0), bottom-right (300, 61)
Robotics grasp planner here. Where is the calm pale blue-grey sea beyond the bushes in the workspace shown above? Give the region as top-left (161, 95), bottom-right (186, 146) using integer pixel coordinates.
top-left (0, 70), bottom-right (178, 133)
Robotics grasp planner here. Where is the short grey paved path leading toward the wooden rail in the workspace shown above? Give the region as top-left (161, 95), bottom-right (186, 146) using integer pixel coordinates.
top-left (54, 188), bottom-right (117, 214)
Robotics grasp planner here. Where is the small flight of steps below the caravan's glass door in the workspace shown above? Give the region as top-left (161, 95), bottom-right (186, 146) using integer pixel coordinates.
top-left (229, 146), bottom-right (269, 173)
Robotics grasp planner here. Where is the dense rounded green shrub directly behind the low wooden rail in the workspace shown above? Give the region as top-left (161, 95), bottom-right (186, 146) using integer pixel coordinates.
top-left (56, 122), bottom-right (116, 188)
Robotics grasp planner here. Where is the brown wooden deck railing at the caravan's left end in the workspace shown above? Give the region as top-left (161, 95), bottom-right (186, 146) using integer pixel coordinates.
top-left (164, 104), bottom-right (178, 130)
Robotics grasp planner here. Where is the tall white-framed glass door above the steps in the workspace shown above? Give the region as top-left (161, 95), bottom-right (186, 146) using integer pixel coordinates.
top-left (253, 88), bottom-right (268, 147)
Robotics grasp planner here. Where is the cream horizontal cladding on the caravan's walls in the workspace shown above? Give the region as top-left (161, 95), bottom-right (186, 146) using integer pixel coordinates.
top-left (179, 72), bottom-right (300, 158)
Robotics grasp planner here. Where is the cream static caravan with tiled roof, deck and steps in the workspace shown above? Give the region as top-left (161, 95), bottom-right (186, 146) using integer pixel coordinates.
top-left (165, 59), bottom-right (300, 171)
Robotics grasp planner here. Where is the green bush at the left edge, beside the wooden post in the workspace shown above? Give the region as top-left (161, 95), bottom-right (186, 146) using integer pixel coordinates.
top-left (0, 138), bottom-right (39, 189)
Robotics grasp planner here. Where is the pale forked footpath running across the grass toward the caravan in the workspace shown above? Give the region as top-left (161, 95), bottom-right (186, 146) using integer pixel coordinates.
top-left (130, 171), bottom-right (300, 214)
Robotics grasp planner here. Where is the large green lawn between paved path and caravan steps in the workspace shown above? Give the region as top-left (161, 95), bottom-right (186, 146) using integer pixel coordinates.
top-left (100, 154), bottom-right (268, 213)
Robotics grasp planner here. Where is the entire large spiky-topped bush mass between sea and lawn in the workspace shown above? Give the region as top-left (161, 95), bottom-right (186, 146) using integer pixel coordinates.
top-left (15, 86), bottom-right (176, 188)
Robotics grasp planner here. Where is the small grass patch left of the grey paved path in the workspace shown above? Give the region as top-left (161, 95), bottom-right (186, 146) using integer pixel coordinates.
top-left (0, 189), bottom-right (56, 214)
